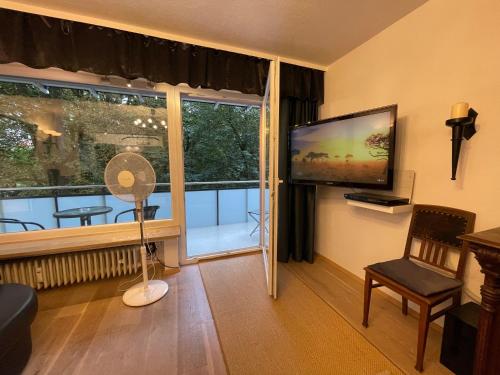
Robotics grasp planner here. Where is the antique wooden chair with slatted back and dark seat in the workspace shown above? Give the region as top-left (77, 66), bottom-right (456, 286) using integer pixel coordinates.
top-left (363, 205), bottom-right (476, 371)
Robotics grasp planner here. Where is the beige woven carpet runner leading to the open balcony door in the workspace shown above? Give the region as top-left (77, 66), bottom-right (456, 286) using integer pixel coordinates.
top-left (199, 255), bottom-right (402, 375)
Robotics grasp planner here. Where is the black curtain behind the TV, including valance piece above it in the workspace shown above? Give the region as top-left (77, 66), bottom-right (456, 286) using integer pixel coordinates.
top-left (277, 63), bottom-right (324, 263)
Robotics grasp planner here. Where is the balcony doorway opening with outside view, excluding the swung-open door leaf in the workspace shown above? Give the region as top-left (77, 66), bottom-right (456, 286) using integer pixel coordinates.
top-left (180, 90), bottom-right (268, 260)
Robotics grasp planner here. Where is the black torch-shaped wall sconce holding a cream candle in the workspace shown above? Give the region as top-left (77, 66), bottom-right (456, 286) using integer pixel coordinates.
top-left (446, 103), bottom-right (478, 180)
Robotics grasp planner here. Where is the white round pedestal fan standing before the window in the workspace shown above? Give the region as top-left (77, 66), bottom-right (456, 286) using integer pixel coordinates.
top-left (104, 152), bottom-right (168, 306)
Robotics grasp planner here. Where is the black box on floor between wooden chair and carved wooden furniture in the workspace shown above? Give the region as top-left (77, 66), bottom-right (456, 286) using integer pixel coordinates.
top-left (440, 302), bottom-right (481, 375)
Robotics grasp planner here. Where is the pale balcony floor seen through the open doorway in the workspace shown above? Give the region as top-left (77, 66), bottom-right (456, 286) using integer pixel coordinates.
top-left (187, 222), bottom-right (259, 257)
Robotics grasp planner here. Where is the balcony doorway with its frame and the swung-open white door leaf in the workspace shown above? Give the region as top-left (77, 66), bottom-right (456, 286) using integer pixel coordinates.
top-left (172, 62), bottom-right (279, 297)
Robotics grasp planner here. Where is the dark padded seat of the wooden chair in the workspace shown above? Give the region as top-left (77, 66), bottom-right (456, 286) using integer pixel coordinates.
top-left (368, 258), bottom-right (462, 297)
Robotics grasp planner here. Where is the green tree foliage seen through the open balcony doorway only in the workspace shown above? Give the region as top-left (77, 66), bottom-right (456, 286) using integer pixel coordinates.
top-left (183, 101), bottom-right (259, 182)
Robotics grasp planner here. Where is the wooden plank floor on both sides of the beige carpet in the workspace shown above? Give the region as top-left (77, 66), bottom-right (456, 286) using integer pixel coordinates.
top-left (24, 254), bottom-right (451, 375)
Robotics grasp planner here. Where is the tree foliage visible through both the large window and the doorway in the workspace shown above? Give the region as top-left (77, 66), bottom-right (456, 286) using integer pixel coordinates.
top-left (0, 82), bottom-right (259, 196)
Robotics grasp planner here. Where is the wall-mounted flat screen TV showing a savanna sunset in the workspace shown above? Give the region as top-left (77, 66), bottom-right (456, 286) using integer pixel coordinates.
top-left (289, 105), bottom-right (397, 190)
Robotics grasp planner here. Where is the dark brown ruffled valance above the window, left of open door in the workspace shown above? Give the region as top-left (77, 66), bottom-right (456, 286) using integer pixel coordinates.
top-left (0, 9), bottom-right (269, 96)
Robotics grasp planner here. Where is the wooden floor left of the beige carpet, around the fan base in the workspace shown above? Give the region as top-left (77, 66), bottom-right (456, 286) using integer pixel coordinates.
top-left (24, 265), bottom-right (226, 375)
